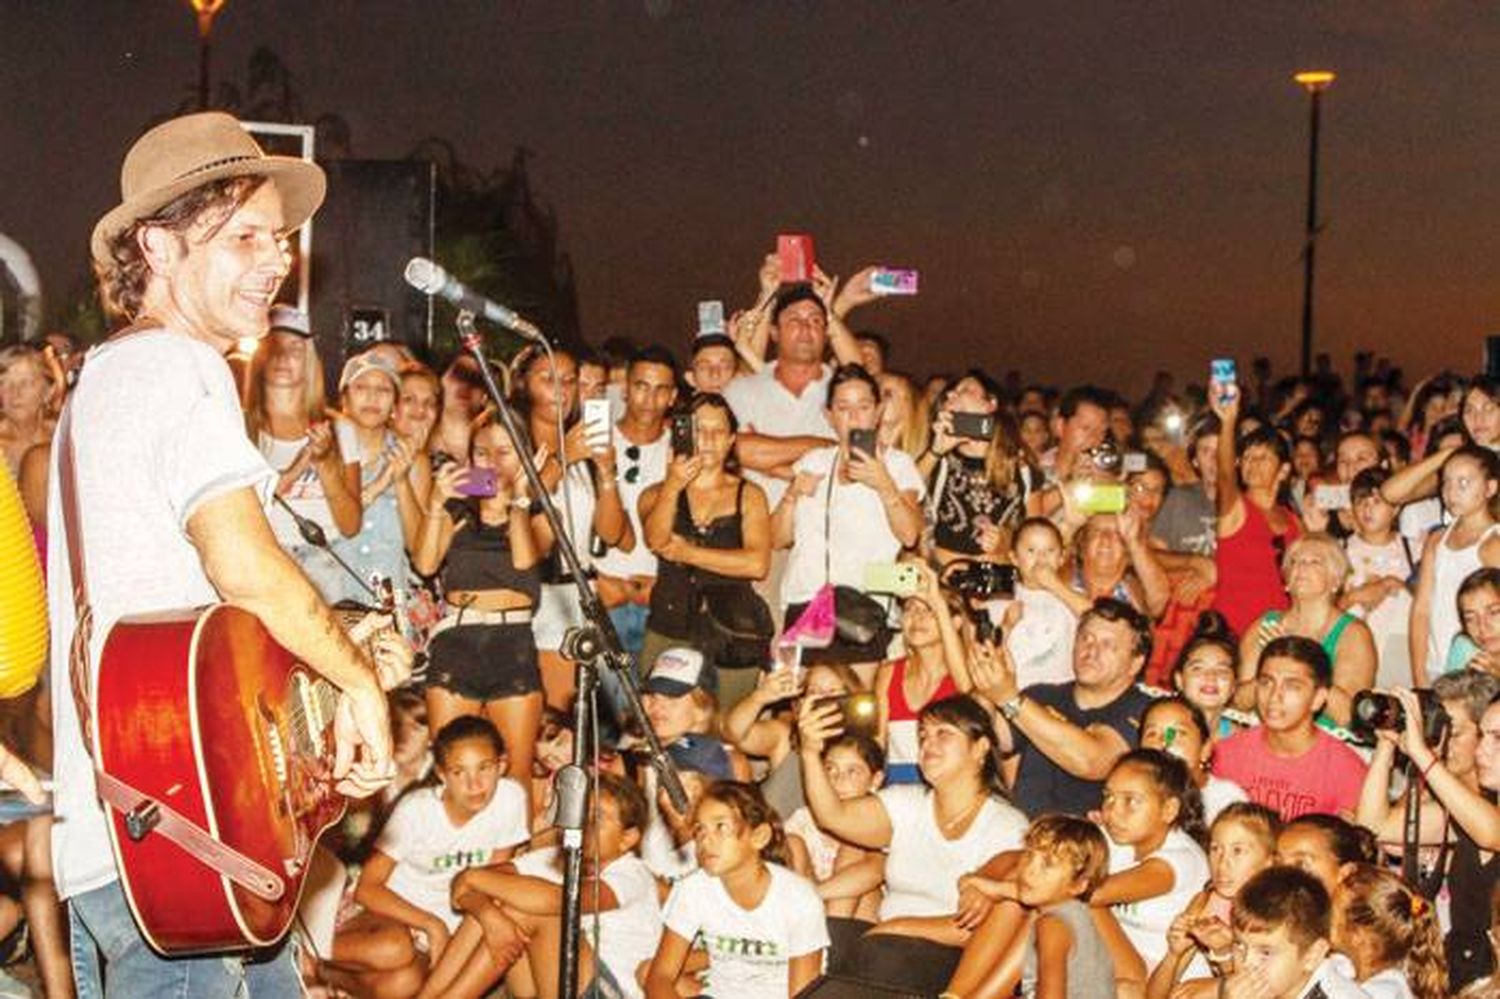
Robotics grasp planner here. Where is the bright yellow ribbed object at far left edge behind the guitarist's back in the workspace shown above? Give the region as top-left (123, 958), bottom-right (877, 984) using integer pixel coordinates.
top-left (0, 462), bottom-right (47, 698)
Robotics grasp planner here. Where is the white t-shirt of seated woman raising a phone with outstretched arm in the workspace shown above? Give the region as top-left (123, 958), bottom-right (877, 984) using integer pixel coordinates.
top-left (876, 785), bottom-right (1026, 920)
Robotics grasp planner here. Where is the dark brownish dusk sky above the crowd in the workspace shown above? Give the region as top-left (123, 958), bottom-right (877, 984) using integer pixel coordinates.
top-left (0, 0), bottom-right (1500, 392)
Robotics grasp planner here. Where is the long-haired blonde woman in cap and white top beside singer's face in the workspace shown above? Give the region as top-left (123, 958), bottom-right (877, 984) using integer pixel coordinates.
top-left (245, 306), bottom-right (363, 600)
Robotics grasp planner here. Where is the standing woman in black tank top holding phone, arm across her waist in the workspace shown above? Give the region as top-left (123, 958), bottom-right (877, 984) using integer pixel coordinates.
top-left (641, 393), bottom-right (771, 671)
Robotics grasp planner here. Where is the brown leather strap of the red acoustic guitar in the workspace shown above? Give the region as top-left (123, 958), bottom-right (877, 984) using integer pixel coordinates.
top-left (57, 323), bottom-right (287, 902)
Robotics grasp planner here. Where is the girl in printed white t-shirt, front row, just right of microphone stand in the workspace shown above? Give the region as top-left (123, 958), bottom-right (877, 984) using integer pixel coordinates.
top-left (645, 780), bottom-right (828, 999)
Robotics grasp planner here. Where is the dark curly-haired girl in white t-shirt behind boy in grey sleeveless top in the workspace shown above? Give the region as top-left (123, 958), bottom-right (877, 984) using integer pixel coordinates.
top-left (1091, 749), bottom-right (1209, 969)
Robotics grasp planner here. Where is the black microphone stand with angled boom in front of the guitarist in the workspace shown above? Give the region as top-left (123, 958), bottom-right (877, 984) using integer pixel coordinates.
top-left (458, 311), bottom-right (687, 999)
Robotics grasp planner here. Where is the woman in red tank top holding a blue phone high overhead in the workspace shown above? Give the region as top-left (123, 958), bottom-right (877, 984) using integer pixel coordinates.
top-left (1209, 386), bottom-right (1301, 635)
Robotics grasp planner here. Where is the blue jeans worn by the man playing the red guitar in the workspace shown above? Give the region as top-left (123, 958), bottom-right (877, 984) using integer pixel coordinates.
top-left (68, 882), bottom-right (302, 999)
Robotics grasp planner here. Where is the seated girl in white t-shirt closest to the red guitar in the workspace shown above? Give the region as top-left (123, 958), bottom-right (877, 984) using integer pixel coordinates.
top-left (326, 716), bottom-right (530, 995)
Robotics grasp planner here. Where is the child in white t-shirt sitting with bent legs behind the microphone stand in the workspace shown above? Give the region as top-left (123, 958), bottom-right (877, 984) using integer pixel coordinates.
top-left (419, 773), bottom-right (662, 999)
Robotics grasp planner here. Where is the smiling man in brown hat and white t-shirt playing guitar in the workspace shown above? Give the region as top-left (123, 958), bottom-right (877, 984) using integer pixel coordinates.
top-left (48, 113), bottom-right (392, 999)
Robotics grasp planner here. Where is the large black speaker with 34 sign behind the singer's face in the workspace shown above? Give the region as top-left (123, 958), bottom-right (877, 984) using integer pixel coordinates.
top-left (311, 159), bottom-right (437, 393)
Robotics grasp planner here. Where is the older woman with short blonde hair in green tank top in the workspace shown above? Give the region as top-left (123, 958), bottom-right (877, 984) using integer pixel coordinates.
top-left (1235, 533), bottom-right (1376, 725)
